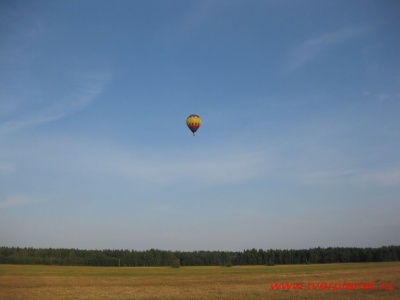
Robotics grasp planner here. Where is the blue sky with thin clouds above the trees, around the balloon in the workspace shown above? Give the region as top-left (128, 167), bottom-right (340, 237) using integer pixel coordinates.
top-left (0, 0), bottom-right (400, 251)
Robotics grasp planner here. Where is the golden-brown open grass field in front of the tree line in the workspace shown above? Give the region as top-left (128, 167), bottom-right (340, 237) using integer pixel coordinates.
top-left (0, 262), bottom-right (400, 299)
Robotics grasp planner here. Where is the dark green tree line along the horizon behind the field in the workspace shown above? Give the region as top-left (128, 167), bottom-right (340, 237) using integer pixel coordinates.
top-left (0, 246), bottom-right (400, 267)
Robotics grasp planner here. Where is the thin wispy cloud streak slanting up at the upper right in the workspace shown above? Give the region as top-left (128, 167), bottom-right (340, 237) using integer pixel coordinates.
top-left (287, 27), bottom-right (366, 70)
